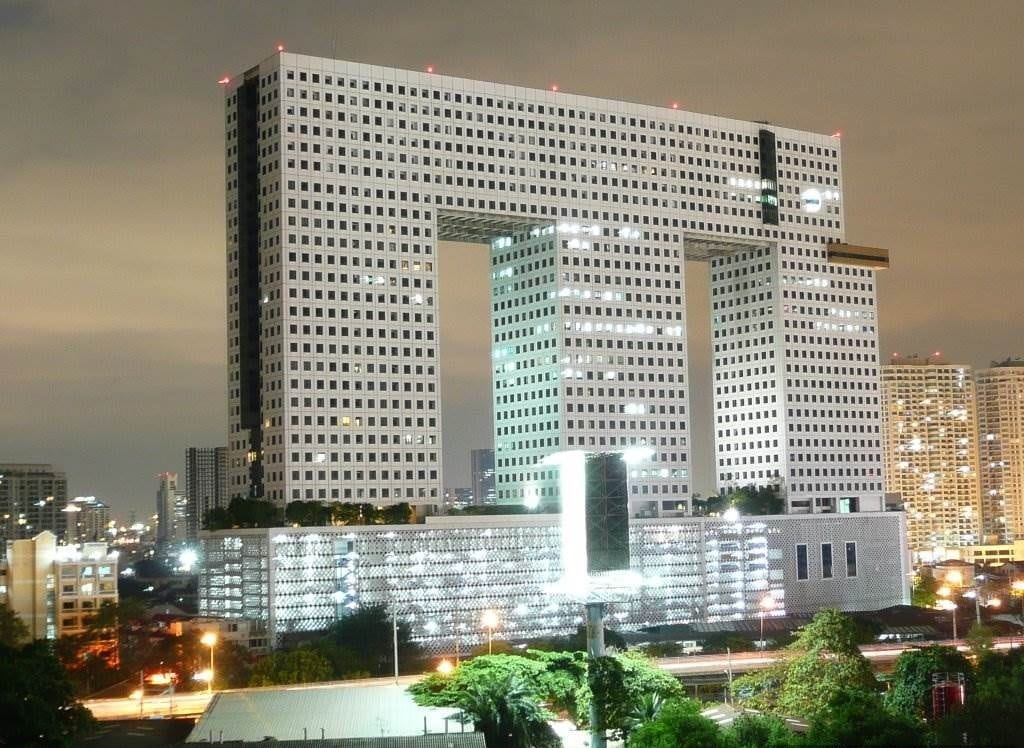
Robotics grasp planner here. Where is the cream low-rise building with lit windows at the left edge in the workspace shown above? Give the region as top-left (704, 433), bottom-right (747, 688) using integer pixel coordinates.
top-left (0, 531), bottom-right (118, 639)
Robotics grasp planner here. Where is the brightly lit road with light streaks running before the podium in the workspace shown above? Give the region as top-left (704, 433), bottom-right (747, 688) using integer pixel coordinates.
top-left (83, 637), bottom-right (1024, 721)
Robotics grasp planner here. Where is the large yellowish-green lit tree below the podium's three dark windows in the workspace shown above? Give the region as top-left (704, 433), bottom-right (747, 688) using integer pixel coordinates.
top-left (733, 610), bottom-right (878, 719)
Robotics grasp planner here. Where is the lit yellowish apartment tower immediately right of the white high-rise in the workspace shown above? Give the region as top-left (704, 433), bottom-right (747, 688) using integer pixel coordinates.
top-left (882, 357), bottom-right (981, 563)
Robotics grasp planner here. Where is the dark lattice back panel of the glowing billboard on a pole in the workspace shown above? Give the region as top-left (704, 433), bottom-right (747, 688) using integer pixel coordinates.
top-left (587, 453), bottom-right (630, 574)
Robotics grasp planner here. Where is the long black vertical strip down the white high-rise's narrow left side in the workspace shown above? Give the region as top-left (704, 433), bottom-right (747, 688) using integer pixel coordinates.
top-left (238, 68), bottom-right (263, 498)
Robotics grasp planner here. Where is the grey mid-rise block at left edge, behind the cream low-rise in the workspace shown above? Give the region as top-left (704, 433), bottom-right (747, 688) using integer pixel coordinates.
top-left (0, 463), bottom-right (68, 541)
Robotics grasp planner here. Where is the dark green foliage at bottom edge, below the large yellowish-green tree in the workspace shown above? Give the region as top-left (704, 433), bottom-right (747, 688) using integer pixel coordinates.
top-left (807, 690), bottom-right (925, 748)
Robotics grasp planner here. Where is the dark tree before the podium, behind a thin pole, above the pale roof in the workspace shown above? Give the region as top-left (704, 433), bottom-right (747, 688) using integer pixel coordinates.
top-left (311, 606), bottom-right (423, 678)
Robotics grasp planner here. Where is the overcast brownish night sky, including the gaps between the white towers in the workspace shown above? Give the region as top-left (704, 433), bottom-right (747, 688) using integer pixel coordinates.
top-left (0, 0), bottom-right (1024, 518)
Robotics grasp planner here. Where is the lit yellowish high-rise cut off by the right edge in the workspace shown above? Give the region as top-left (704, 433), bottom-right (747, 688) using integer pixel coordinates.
top-left (976, 359), bottom-right (1024, 543)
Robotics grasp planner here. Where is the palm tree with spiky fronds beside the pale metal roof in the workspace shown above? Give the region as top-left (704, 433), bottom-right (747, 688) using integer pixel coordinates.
top-left (459, 673), bottom-right (558, 748)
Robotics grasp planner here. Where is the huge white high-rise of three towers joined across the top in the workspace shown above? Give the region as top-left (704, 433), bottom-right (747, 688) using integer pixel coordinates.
top-left (224, 52), bottom-right (888, 516)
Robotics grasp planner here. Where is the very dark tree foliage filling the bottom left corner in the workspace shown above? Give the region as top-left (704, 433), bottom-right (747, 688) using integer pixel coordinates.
top-left (0, 640), bottom-right (94, 746)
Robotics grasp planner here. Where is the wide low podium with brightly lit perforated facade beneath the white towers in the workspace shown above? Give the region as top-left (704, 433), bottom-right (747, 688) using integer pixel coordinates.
top-left (199, 512), bottom-right (909, 651)
